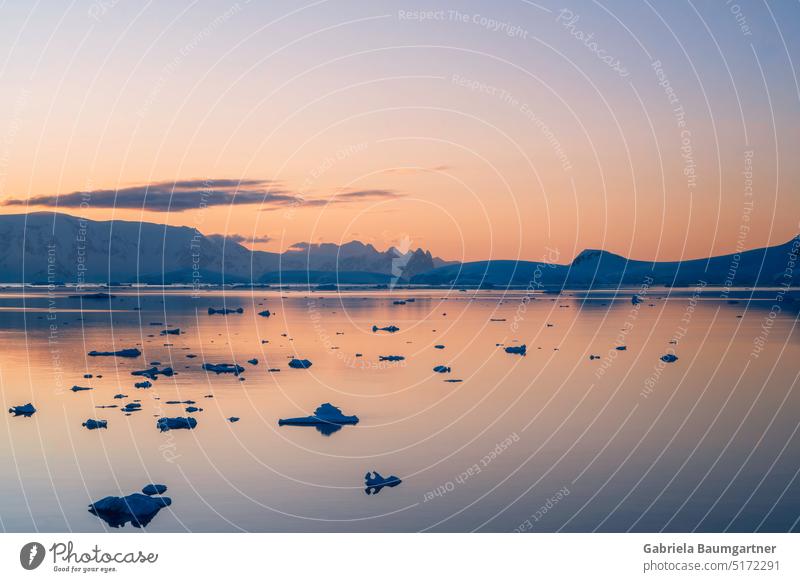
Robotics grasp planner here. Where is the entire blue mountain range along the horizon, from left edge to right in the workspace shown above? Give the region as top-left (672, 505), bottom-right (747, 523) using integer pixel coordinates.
top-left (0, 212), bottom-right (800, 289)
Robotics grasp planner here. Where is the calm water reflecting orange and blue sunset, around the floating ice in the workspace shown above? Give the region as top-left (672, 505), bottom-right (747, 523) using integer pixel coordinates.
top-left (0, 290), bottom-right (800, 532)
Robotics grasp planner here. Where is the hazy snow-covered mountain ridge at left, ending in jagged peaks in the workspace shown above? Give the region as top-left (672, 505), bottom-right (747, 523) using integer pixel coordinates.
top-left (0, 212), bottom-right (449, 284)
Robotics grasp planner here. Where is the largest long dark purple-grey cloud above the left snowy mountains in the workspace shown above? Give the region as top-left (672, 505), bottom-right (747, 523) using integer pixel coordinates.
top-left (2, 179), bottom-right (304, 212)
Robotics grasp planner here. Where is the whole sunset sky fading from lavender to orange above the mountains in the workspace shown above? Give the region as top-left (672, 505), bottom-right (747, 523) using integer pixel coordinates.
top-left (0, 0), bottom-right (800, 262)
